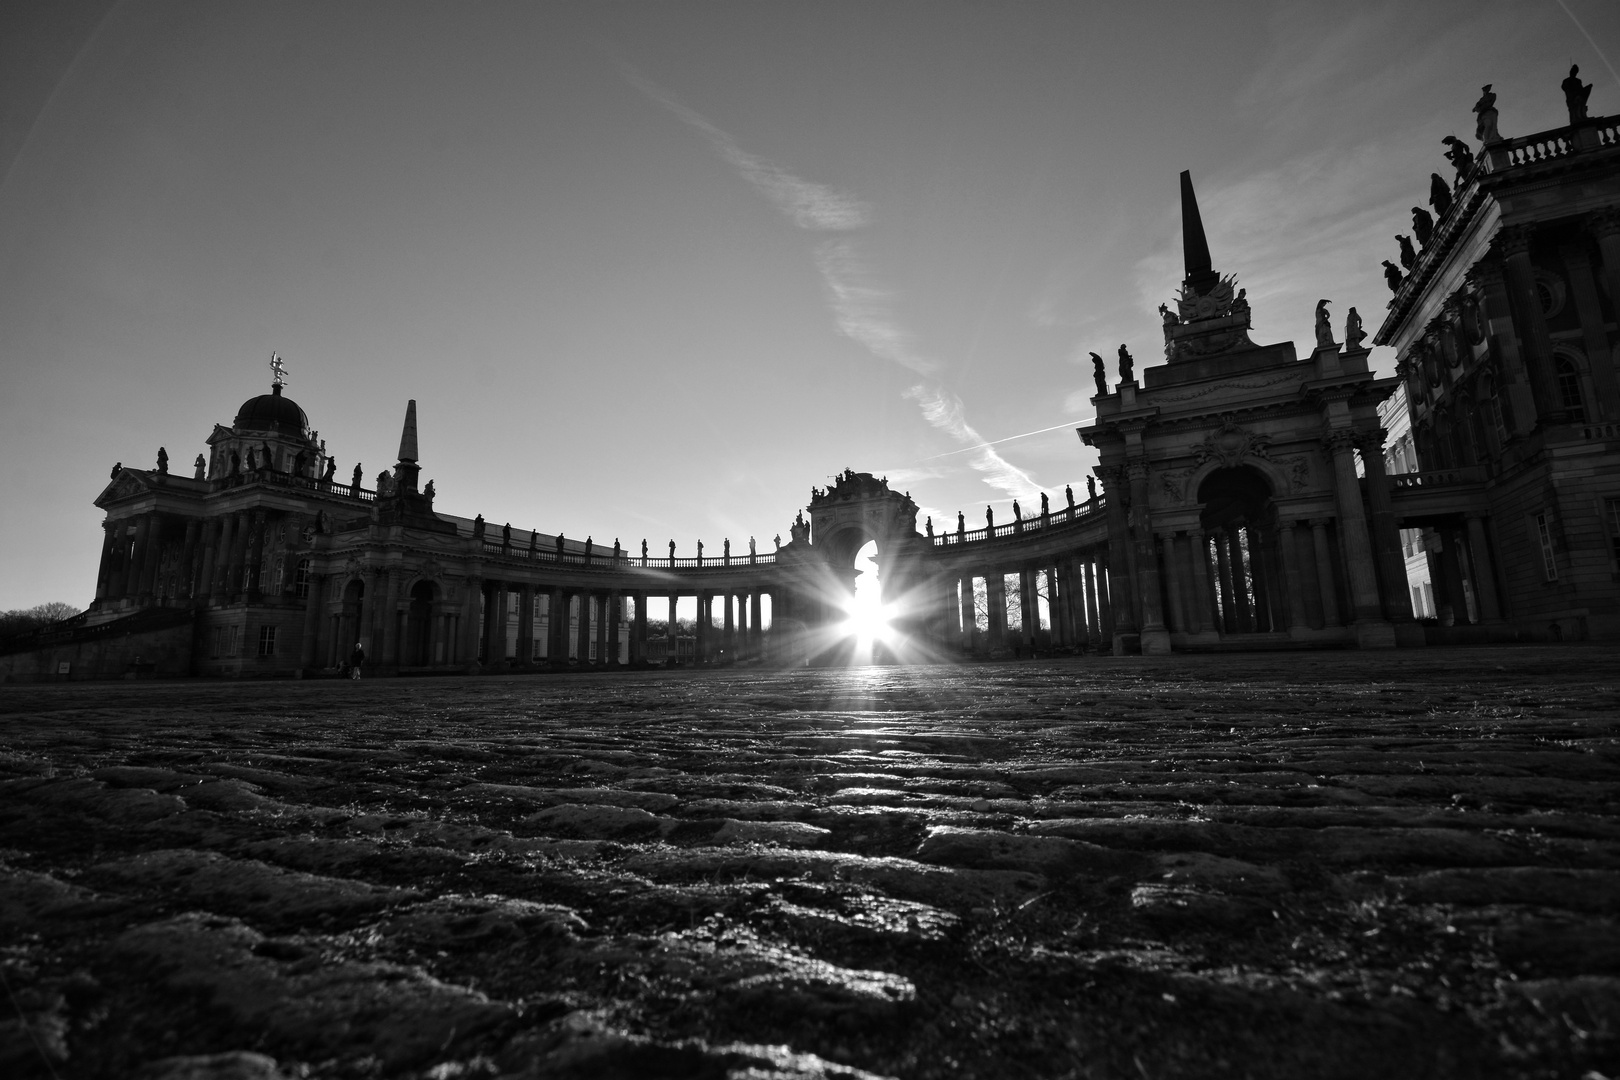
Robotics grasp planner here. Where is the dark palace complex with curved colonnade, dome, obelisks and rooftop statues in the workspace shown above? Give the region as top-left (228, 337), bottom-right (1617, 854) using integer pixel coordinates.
top-left (0, 76), bottom-right (1620, 678)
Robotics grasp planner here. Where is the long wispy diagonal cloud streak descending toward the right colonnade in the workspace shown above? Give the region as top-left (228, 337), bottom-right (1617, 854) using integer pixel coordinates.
top-left (622, 66), bottom-right (1038, 497)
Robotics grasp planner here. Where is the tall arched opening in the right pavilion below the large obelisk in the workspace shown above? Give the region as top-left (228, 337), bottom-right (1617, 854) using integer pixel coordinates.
top-left (1197, 465), bottom-right (1286, 633)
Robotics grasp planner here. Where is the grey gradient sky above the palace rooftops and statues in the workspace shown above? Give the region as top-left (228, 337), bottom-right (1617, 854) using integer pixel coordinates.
top-left (0, 0), bottom-right (1620, 609)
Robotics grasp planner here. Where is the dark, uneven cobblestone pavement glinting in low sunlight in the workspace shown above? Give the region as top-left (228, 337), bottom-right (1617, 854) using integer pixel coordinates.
top-left (0, 648), bottom-right (1620, 1080)
